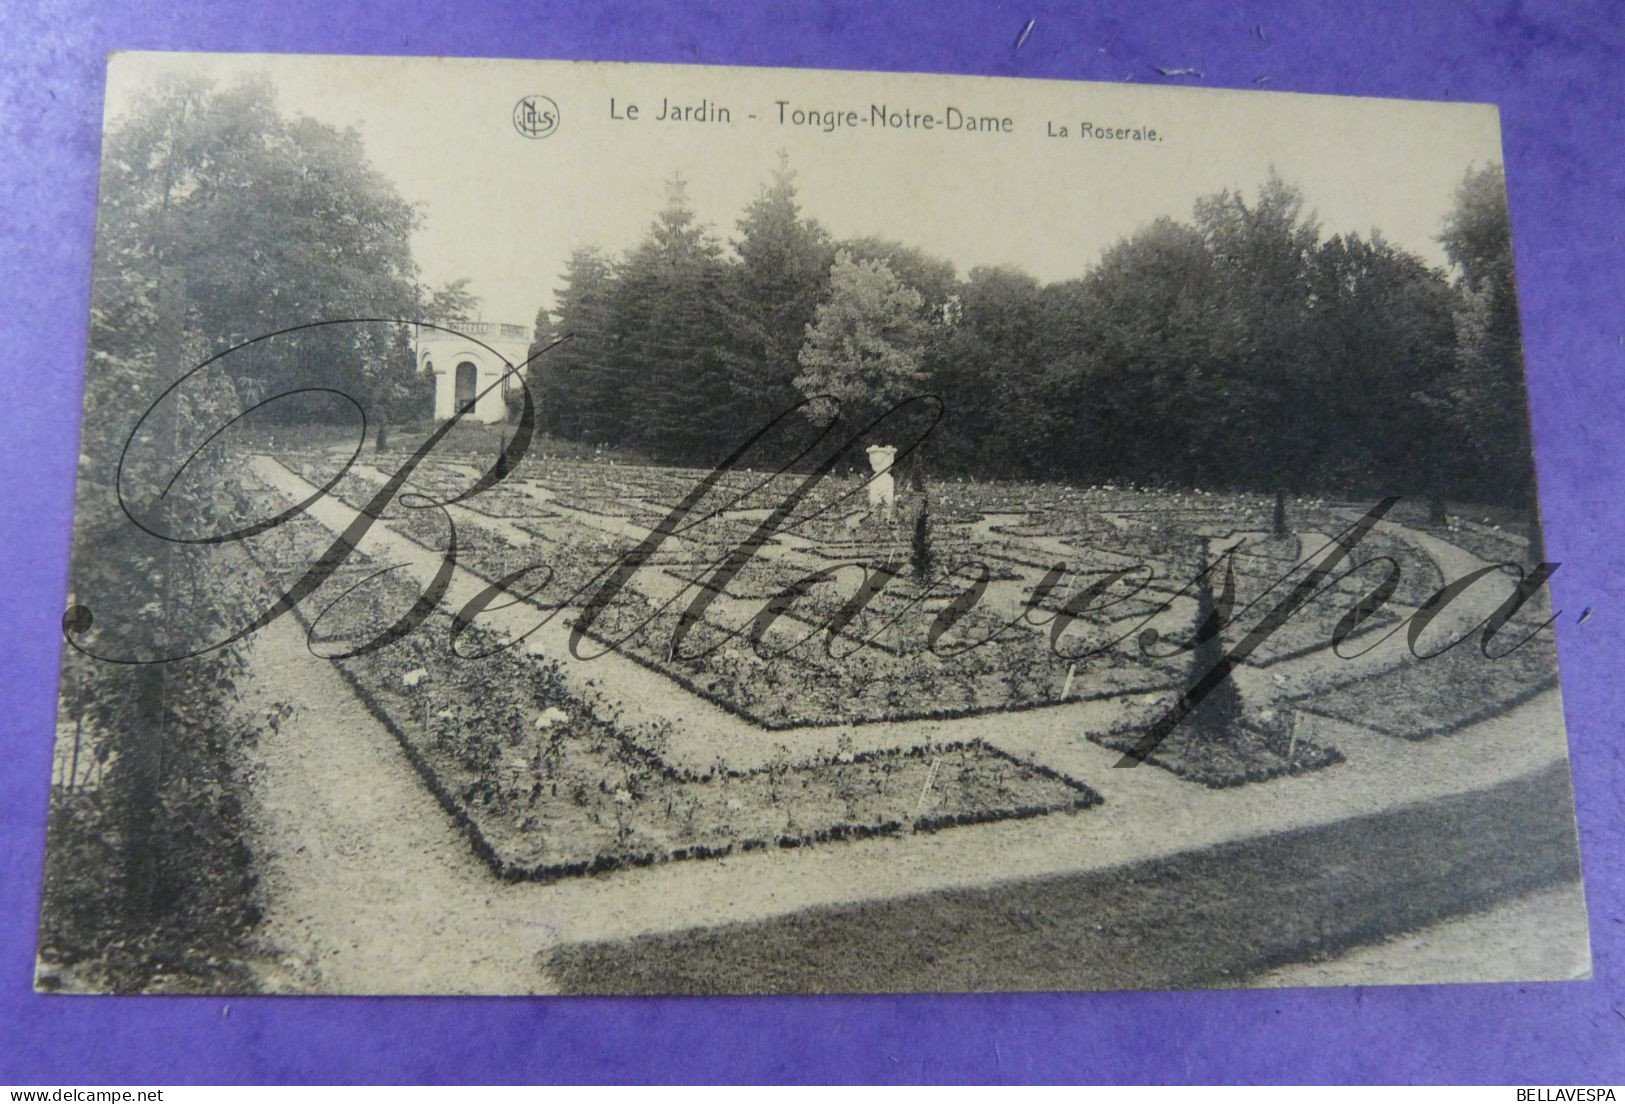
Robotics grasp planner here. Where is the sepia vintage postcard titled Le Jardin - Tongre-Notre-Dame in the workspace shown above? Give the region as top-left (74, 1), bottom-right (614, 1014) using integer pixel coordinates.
top-left (36, 54), bottom-right (1589, 993)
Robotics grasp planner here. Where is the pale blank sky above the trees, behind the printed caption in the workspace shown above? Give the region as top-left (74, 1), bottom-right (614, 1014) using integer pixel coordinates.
top-left (107, 52), bottom-right (1502, 325)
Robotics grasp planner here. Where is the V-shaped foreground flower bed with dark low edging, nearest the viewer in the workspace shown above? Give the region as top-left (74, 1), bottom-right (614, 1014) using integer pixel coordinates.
top-left (240, 487), bottom-right (1100, 880)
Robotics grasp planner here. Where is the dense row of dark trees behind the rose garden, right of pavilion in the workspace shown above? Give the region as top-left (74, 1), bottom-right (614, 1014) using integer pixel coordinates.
top-left (536, 164), bottom-right (1532, 504)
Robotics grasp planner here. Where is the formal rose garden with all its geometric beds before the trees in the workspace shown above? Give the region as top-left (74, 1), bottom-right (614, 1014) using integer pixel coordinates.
top-left (216, 435), bottom-right (1552, 880)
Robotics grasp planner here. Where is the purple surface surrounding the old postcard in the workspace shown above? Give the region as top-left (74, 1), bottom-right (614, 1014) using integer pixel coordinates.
top-left (0, 0), bottom-right (1625, 1084)
